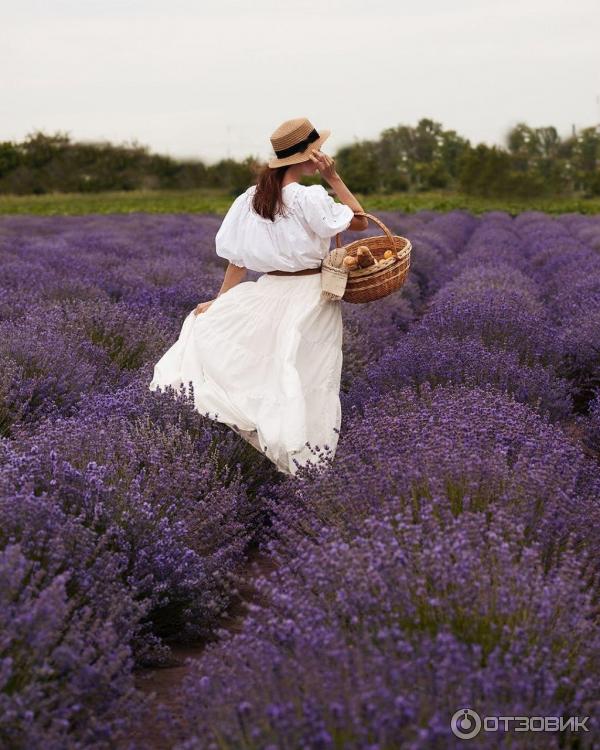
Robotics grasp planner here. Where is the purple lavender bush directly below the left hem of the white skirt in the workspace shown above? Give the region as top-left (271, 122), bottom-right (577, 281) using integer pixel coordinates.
top-left (3, 383), bottom-right (272, 660)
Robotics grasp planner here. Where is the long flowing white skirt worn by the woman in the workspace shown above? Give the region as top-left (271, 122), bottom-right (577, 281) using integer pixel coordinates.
top-left (149, 273), bottom-right (343, 475)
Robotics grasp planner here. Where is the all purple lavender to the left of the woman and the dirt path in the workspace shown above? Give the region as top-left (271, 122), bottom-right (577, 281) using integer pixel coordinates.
top-left (0, 209), bottom-right (433, 748)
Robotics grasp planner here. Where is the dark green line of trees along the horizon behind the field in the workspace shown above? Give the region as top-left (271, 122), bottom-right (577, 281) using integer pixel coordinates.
top-left (0, 118), bottom-right (600, 198)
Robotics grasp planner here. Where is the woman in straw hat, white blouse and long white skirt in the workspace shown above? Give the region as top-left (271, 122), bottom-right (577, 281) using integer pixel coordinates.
top-left (149, 117), bottom-right (367, 475)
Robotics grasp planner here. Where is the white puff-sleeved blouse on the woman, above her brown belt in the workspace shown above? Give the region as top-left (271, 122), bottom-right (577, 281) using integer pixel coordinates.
top-left (215, 182), bottom-right (354, 273)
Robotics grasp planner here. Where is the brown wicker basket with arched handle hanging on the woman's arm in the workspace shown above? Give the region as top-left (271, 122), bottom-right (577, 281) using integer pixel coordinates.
top-left (335, 212), bottom-right (412, 302)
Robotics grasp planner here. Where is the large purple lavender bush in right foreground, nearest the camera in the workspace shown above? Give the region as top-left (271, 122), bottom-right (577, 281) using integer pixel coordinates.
top-left (177, 508), bottom-right (600, 750)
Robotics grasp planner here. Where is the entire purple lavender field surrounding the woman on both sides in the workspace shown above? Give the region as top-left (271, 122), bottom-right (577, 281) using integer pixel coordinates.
top-left (0, 210), bottom-right (600, 750)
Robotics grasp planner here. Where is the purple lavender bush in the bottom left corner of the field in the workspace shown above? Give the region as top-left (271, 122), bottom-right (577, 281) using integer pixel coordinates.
top-left (0, 478), bottom-right (152, 750)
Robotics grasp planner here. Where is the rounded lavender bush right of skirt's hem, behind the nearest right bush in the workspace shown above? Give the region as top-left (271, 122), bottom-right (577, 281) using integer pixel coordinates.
top-left (272, 383), bottom-right (600, 588)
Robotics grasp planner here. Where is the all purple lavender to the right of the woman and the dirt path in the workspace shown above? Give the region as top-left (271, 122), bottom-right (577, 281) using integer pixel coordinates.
top-left (173, 212), bottom-right (600, 750)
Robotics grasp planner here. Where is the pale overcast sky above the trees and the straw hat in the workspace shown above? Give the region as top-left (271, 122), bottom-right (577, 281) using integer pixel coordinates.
top-left (0, 0), bottom-right (600, 162)
